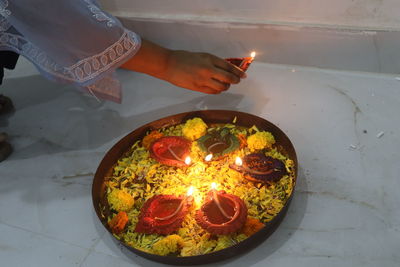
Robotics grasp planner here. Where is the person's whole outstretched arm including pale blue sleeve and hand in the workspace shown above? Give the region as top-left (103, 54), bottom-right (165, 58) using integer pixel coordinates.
top-left (0, 0), bottom-right (244, 102)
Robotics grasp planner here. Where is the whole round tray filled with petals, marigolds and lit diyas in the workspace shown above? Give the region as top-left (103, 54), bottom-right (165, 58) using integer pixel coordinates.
top-left (92, 110), bottom-right (297, 265)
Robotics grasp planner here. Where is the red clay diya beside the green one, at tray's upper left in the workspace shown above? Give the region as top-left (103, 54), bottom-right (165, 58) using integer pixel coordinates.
top-left (150, 136), bottom-right (191, 167)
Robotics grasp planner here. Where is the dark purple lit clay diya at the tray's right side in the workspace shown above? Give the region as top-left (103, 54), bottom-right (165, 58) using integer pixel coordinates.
top-left (229, 153), bottom-right (287, 183)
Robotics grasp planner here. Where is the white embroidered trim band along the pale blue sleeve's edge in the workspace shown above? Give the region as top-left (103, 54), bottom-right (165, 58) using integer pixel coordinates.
top-left (0, 29), bottom-right (140, 85)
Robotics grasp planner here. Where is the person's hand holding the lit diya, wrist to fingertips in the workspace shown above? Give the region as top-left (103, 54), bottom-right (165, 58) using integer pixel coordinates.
top-left (163, 51), bottom-right (246, 94)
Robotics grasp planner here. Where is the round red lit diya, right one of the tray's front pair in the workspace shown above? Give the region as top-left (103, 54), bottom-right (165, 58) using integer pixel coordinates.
top-left (195, 183), bottom-right (247, 235)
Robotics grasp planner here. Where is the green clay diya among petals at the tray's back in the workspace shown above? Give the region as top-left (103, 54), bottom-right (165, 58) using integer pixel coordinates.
top-left (197, 128), bottom-right (240, 161)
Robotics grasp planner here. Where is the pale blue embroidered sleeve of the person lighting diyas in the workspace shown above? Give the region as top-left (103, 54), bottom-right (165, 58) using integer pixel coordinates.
top-left (0, 0), bottom-right (141, 102)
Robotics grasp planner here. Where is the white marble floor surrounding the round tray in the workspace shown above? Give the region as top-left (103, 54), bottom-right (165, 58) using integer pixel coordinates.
top-left (0, 59), bottom-right (400, 266)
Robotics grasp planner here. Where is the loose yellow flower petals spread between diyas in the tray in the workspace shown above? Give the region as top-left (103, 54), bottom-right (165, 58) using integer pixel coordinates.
top-left (103, 120), bottom-right (294, 257)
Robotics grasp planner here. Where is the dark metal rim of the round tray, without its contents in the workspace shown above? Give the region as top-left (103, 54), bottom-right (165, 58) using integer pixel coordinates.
top-left (92, 110), bottom-right (298, 265)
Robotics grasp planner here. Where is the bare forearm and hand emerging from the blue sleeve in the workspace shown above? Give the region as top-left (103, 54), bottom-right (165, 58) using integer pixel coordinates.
top-left (121, 39), bottom-right (246, 94)
